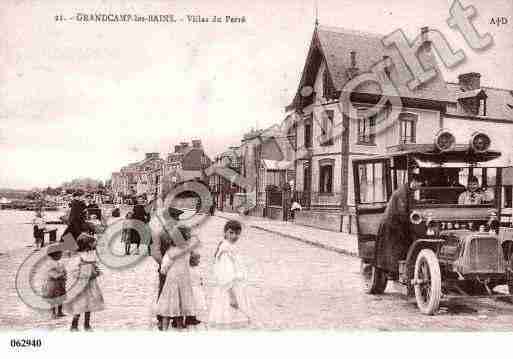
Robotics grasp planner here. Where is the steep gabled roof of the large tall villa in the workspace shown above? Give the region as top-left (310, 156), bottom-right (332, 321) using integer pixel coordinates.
top-left (290, 26), bottom-right (449, 107)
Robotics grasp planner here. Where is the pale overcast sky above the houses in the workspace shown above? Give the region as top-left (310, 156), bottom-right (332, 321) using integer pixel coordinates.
top-left (0, 0), bottom-right (513, 188)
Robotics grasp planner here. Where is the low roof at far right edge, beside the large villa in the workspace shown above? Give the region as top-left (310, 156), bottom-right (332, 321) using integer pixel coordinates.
top-left (447, 82), bottom-right (513, 122)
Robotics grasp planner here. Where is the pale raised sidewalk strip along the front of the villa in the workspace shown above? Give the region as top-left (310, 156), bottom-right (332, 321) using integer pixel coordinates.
top-left (216, 211), bottom-right (358, 256)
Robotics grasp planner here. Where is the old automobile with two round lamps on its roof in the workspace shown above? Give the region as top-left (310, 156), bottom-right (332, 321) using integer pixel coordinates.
top-left (353, 130), bottom-right (513, 315)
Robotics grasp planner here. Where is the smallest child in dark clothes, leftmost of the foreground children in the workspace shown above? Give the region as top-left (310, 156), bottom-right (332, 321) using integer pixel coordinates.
top-left (43, 245), bottom-right (67, 319)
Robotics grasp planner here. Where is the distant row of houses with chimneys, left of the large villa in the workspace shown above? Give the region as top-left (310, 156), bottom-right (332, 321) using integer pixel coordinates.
top-left (111, 140), bottom-right (211, 203)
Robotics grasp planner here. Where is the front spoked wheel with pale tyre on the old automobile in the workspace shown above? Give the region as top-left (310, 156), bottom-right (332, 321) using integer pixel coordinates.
top-left (413, 249), bottom-right (442, 315)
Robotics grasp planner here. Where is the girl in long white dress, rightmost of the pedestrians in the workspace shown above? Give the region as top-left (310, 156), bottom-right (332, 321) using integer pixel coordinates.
top-left (208, 220), bottom-right (251, 329)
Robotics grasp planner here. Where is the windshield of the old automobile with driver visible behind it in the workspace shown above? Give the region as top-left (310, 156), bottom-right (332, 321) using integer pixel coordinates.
top-left (413, 167), bottom-right (497, 206)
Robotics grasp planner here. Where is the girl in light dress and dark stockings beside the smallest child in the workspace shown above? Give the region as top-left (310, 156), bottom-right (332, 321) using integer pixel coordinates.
top-left (65, 233), bottom-right (105, 331)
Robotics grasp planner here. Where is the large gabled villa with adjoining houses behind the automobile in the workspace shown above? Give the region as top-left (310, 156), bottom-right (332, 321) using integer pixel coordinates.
top-left (210, 25), bottom-right (513, 232)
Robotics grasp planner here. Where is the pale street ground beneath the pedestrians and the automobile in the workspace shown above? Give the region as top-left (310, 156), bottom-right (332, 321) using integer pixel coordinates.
top-left (0, 213), bottom-right (513, 335)
